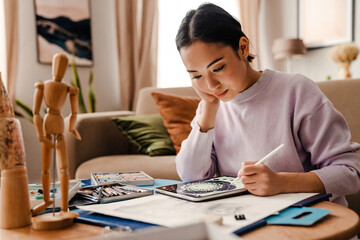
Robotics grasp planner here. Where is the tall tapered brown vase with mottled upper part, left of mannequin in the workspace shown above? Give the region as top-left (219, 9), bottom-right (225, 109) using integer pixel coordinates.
top-left (0, 75), bottom-right (31, 229)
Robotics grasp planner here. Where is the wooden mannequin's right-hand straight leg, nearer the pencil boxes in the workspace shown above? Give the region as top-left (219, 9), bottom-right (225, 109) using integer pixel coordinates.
top-left (56, 134), bottom-right (69, 212)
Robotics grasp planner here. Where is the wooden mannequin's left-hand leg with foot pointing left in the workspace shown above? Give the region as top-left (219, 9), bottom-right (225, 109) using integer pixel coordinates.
top-left (32, 134), bottom-right (53, 216)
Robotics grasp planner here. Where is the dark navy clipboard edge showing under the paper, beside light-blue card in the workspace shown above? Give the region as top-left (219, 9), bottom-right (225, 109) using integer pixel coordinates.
top-left (233, 193), bottom-right (332, 236)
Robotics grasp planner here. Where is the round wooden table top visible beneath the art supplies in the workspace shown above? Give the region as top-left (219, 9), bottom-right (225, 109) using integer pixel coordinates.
top-left (0, 202), bottom-right (360, 240)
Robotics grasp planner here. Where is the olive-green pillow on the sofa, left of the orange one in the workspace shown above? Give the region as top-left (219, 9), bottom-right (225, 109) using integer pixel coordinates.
top-left (112, 114), bottom-right (176, 156)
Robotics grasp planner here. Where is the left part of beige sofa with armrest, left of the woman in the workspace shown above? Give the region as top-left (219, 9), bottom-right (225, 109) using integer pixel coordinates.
top-left (65, 87), bottom-right (197, 180)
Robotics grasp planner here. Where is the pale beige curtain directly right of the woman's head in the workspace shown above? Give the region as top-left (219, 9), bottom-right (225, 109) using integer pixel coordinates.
top-left (239, 0), bottom-right (260, 70)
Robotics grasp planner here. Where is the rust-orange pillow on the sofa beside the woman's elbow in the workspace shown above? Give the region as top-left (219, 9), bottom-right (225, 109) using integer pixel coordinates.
top-left (151, 92), bottom-right (201, 153)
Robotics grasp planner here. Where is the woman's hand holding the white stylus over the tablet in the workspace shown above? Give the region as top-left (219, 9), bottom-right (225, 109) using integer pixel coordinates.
top-left (238, 161), bottom-right (284, 196)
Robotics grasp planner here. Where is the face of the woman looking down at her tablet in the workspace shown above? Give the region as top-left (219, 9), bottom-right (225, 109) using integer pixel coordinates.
top-left (180, 41), bottom-right (253, 101)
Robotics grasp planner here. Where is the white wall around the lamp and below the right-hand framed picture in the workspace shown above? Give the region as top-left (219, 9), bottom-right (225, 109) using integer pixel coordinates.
top-left (259, 0), bottom-right (360, 81)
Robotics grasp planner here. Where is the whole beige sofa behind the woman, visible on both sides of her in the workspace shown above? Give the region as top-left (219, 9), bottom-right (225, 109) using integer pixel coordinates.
top-left (65, 79), bottom-right (360, 216)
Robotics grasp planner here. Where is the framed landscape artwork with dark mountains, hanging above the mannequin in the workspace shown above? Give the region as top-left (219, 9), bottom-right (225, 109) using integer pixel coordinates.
top-left (34, 0), bottom-right (93, 66)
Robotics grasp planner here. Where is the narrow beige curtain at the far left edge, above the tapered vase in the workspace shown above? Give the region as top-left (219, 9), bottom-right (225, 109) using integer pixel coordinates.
top-left (2, 0), bottom-right (19, 103)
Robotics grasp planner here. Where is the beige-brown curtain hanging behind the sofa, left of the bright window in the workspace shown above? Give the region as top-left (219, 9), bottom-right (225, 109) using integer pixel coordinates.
top-left (115, 0), bottom-right (158, 110)
